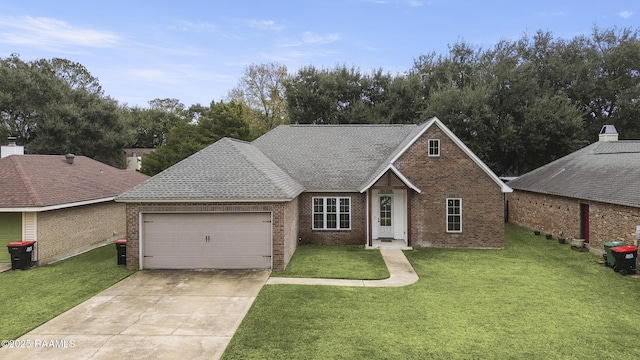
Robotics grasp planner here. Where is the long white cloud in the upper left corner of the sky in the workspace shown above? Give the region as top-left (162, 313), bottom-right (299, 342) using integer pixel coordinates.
top-left (0, 16), bottom-right (121, 48)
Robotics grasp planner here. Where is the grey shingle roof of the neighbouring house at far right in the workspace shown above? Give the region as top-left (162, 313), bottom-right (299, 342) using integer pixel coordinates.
top-left (509, 140), bottom-right (640, 207)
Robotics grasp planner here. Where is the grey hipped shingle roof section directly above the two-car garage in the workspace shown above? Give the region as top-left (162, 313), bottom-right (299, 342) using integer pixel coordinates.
top-left (118, 138), bottom-right (303, 201)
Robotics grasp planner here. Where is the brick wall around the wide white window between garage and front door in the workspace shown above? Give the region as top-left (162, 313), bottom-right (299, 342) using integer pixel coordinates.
top-left (298, 193), bottom-right (367, 245)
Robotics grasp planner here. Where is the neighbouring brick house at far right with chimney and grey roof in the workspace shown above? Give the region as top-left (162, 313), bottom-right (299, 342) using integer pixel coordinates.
top-left (508, 125), bottom-right (640, 252)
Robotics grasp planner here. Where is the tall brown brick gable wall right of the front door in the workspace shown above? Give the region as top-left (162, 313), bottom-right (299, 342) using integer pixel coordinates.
top-left (394, 126), bottom-right (504, 248)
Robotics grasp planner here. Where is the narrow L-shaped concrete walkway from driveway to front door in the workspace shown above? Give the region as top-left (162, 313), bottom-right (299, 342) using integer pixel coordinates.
top-left (267, 249), bottom-right (418, 287)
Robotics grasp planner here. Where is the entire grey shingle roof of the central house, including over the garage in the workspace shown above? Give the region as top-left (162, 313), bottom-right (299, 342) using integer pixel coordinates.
top-left (117, 118), bottom-right (510, 201)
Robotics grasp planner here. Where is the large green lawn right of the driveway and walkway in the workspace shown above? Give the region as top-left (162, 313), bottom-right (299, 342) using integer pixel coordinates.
top-left (223, 225), bottom-right (640, 359)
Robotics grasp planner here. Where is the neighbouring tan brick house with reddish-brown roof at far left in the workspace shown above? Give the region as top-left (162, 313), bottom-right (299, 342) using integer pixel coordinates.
top-left (0, 154), bottom-right (148, 265)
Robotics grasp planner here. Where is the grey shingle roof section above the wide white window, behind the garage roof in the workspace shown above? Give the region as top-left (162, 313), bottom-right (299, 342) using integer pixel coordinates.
top-left (253, 125), bottom-right (418, 191)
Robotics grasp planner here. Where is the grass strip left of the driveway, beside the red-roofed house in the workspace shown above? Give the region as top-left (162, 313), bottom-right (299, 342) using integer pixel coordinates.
top-left (0, 245), bottom-right (135, 339)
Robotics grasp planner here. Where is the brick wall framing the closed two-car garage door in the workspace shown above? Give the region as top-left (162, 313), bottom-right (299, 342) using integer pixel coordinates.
top-left (126, 200), bottom-right (297, 270)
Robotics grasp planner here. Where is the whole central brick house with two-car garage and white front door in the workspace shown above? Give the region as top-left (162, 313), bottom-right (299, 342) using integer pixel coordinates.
top-left (116, 118), bottom-right (511, 270)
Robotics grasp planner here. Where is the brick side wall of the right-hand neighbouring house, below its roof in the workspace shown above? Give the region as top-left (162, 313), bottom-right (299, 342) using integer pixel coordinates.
top-left (508, 190), bottom-right (640, 249)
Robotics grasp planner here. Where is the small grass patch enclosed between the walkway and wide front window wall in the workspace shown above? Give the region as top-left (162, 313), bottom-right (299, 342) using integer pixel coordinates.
top-left (271, 245), bottom-right (389, 280)
